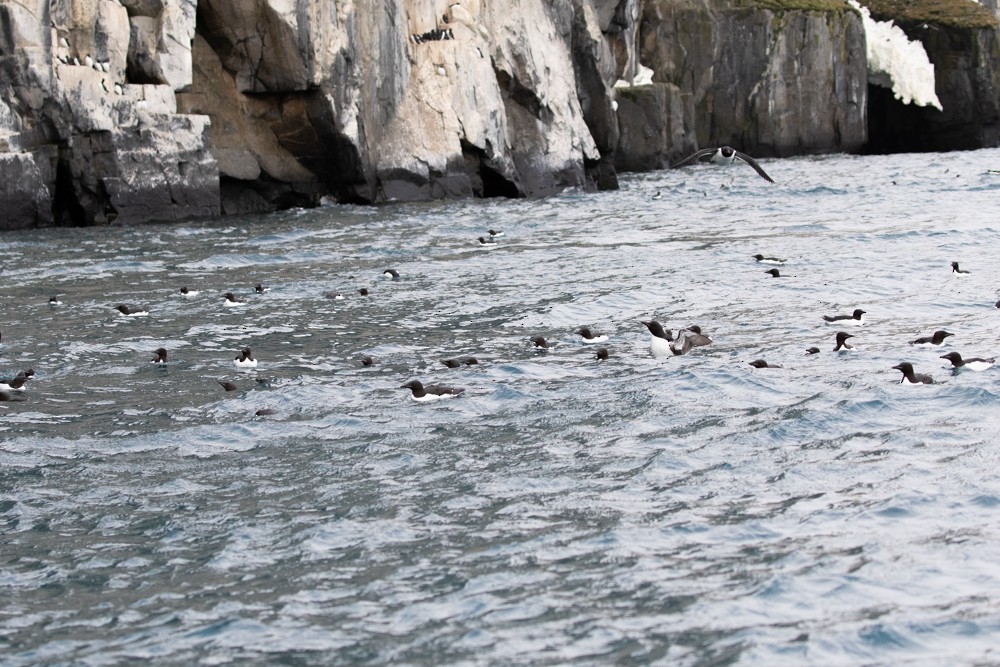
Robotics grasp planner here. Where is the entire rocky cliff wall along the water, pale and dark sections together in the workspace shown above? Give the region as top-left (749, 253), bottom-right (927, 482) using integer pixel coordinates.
top-left (0, 0), bottom-right (1000, 229)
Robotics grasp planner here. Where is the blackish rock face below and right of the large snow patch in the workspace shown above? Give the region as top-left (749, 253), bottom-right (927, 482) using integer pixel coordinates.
top-left (866, 23), bottom-right (1000, 153)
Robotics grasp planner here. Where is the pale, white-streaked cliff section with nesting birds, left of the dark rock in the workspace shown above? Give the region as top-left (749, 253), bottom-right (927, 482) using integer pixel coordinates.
top-left (0, 0), bottom-right (635, 227)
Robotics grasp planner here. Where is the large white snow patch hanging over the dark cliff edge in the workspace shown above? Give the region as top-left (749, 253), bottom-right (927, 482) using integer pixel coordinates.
top-left (847, 0), bottom-right (942, 111)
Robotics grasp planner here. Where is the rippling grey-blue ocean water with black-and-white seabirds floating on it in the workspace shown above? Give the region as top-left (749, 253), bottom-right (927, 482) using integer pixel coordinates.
top-left (0, 150), bottom-right (1000, 667)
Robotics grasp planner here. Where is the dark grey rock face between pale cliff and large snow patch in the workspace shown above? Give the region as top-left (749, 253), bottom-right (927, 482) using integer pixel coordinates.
top-left (636, 0), bottom-right (867, 164)
